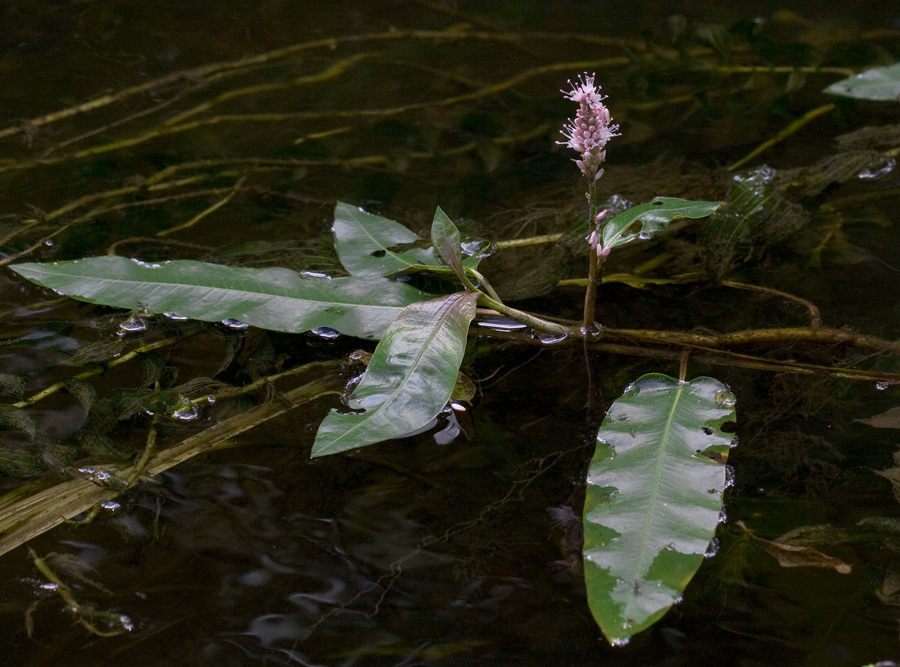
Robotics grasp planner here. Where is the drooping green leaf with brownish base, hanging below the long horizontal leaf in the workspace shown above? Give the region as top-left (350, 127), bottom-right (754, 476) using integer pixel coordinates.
top-left (312, 292), bottom-right (478, 456)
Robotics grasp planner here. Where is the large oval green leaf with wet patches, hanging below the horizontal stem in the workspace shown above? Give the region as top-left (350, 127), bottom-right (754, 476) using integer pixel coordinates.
top-left (583, 373), bottom-right (735, 644)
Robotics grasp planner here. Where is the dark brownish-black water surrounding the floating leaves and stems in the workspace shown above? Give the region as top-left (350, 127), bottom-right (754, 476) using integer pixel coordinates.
top-left (0, 0), bottom-right (900, 666)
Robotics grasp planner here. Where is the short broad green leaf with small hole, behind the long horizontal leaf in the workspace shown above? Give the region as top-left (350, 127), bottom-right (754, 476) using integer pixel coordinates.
top-left (331, 202), bottom-right (440, 278)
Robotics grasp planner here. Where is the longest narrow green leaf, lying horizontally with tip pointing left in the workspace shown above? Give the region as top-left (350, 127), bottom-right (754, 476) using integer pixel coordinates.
top-left (11, 257), bottom-right (431, 338)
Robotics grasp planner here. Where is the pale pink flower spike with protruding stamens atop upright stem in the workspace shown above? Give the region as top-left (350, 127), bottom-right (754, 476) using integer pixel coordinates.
top-left (556, 72), bottom-right (620, 182)
